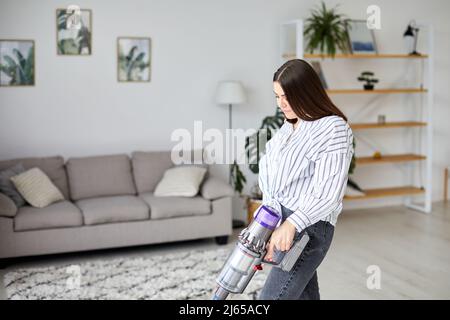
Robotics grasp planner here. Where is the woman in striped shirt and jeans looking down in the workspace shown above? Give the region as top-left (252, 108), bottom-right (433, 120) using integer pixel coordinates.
top-left (259, 59), bottom-right (353, 299)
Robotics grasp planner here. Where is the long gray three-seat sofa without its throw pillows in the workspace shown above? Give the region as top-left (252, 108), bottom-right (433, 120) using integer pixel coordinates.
top-left (0, 151), bottom-right (233, 261)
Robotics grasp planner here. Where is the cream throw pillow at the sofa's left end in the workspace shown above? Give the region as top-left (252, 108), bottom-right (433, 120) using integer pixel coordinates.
top-left (11, 168), bottom-right (64, 208)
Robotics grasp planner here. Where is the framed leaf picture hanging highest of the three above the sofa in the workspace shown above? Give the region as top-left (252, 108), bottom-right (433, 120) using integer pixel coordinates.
top-left (56, 9), bottom-right (92, 55)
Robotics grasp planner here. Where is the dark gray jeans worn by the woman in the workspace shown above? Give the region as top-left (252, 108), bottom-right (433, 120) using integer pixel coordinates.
top-left (259, 207), bottom-right (334, 300)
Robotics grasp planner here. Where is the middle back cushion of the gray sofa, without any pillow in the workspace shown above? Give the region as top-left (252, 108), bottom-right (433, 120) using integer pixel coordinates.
top-left (66, 154), bottom-right (136, 200)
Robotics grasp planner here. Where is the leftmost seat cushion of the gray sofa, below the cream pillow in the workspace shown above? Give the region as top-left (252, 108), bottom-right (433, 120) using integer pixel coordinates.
top-left (14, 201), bottom-right (83, 231)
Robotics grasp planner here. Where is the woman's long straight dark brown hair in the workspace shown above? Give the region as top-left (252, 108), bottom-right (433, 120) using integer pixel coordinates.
top-left (273, 59), bottom-right (347, 123)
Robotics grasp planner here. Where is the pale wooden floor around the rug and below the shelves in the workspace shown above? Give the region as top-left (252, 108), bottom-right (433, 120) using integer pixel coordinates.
top-left (0, 202), bottom-right (450, 299)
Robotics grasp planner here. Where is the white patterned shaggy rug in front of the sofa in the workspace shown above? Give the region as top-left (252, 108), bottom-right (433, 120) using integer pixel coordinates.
top-left (4, 247), bottom-right (268, 300)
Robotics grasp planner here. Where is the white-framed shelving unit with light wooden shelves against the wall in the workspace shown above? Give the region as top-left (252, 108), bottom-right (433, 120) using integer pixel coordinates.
top-left (280, 19), bottom-right (434, 213)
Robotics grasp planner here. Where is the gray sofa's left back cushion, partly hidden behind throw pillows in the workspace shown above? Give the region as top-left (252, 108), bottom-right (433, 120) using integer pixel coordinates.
top-left (0, 156), bottom-right (69, 199)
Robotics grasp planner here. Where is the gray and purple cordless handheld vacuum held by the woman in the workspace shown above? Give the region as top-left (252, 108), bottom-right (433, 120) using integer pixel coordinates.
top-left (212, 205), bottom-right (309, 300)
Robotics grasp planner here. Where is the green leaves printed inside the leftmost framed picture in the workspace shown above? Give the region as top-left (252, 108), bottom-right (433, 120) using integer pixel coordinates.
top-left (0, 46), bottom-right (34, 85)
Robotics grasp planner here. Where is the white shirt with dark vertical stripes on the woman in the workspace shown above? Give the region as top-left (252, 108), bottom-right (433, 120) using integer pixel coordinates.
top-left (259, 116), bottom-right (354, 232)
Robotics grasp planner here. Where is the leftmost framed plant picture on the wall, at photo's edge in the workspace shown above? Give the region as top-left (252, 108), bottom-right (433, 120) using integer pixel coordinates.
top-left (0, 40), bottom-right (35, 86)
